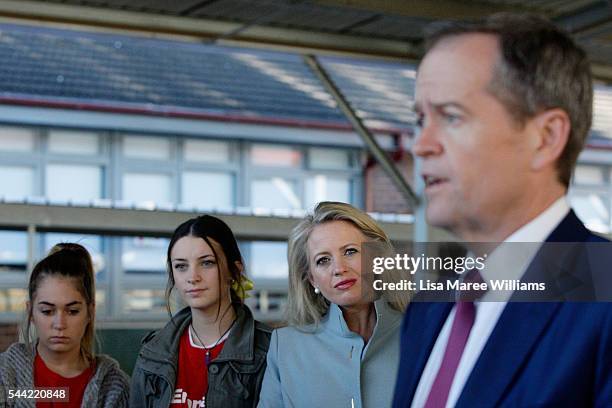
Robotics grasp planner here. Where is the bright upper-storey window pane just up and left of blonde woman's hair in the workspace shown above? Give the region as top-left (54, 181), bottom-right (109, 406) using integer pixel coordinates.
top-left (251, 177), bottom-right (302, 209)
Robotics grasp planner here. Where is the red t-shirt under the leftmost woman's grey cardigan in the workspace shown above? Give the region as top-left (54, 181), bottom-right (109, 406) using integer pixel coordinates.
top-left (34, 354), bottom-right (94, 408)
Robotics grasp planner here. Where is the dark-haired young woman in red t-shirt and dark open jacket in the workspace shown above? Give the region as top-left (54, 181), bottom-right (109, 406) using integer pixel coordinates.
top-left (130, 215), bottom-right (271, 408)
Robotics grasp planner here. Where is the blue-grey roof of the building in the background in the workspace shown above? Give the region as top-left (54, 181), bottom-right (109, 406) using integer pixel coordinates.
top-left (0, 24), bottom-right (612, 144)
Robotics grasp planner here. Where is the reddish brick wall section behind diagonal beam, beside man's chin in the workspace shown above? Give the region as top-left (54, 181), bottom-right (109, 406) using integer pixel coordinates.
top-left (365, 152), bottom-right (413, 214)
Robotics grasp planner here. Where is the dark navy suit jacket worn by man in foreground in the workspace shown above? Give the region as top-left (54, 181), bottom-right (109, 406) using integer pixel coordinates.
top-left (393, 211), bottom-right (612, 408)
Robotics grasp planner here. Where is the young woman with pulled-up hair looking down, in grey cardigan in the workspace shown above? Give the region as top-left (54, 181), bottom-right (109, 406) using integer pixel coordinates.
top-left (0, 243), bottom-right (129, 408)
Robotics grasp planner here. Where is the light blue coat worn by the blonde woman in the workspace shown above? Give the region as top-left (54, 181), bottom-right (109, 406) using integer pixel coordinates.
top-left (258, 300), bottom-right (402, 408)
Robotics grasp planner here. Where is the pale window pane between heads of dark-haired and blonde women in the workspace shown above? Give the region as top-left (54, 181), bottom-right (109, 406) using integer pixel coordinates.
top-left (248, 241), bottom-right (288, 279)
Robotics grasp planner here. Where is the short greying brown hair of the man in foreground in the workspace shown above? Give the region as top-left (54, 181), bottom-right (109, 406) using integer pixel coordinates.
top-left (425, 13), bottom-right (593, 187)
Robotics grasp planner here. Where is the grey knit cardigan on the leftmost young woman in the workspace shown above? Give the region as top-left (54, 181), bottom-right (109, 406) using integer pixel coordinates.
top-left (0, 343), bottom-right (129, 408)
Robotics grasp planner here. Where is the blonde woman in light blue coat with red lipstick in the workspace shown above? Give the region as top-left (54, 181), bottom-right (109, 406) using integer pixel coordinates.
top-left (259, 202), bottom-right (407, 408)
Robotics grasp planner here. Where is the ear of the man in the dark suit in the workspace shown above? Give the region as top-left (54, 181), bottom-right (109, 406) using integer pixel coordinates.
top-left (531, 108), bottom-right (571, 170)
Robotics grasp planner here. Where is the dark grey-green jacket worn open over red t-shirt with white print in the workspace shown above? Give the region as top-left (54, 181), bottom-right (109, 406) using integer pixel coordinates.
top-left (130, 306), bottom-right (272, 408)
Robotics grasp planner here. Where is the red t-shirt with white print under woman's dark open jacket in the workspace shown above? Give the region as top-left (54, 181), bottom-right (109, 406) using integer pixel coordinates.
top-left (170, 327), bottom-right (225, 408)
